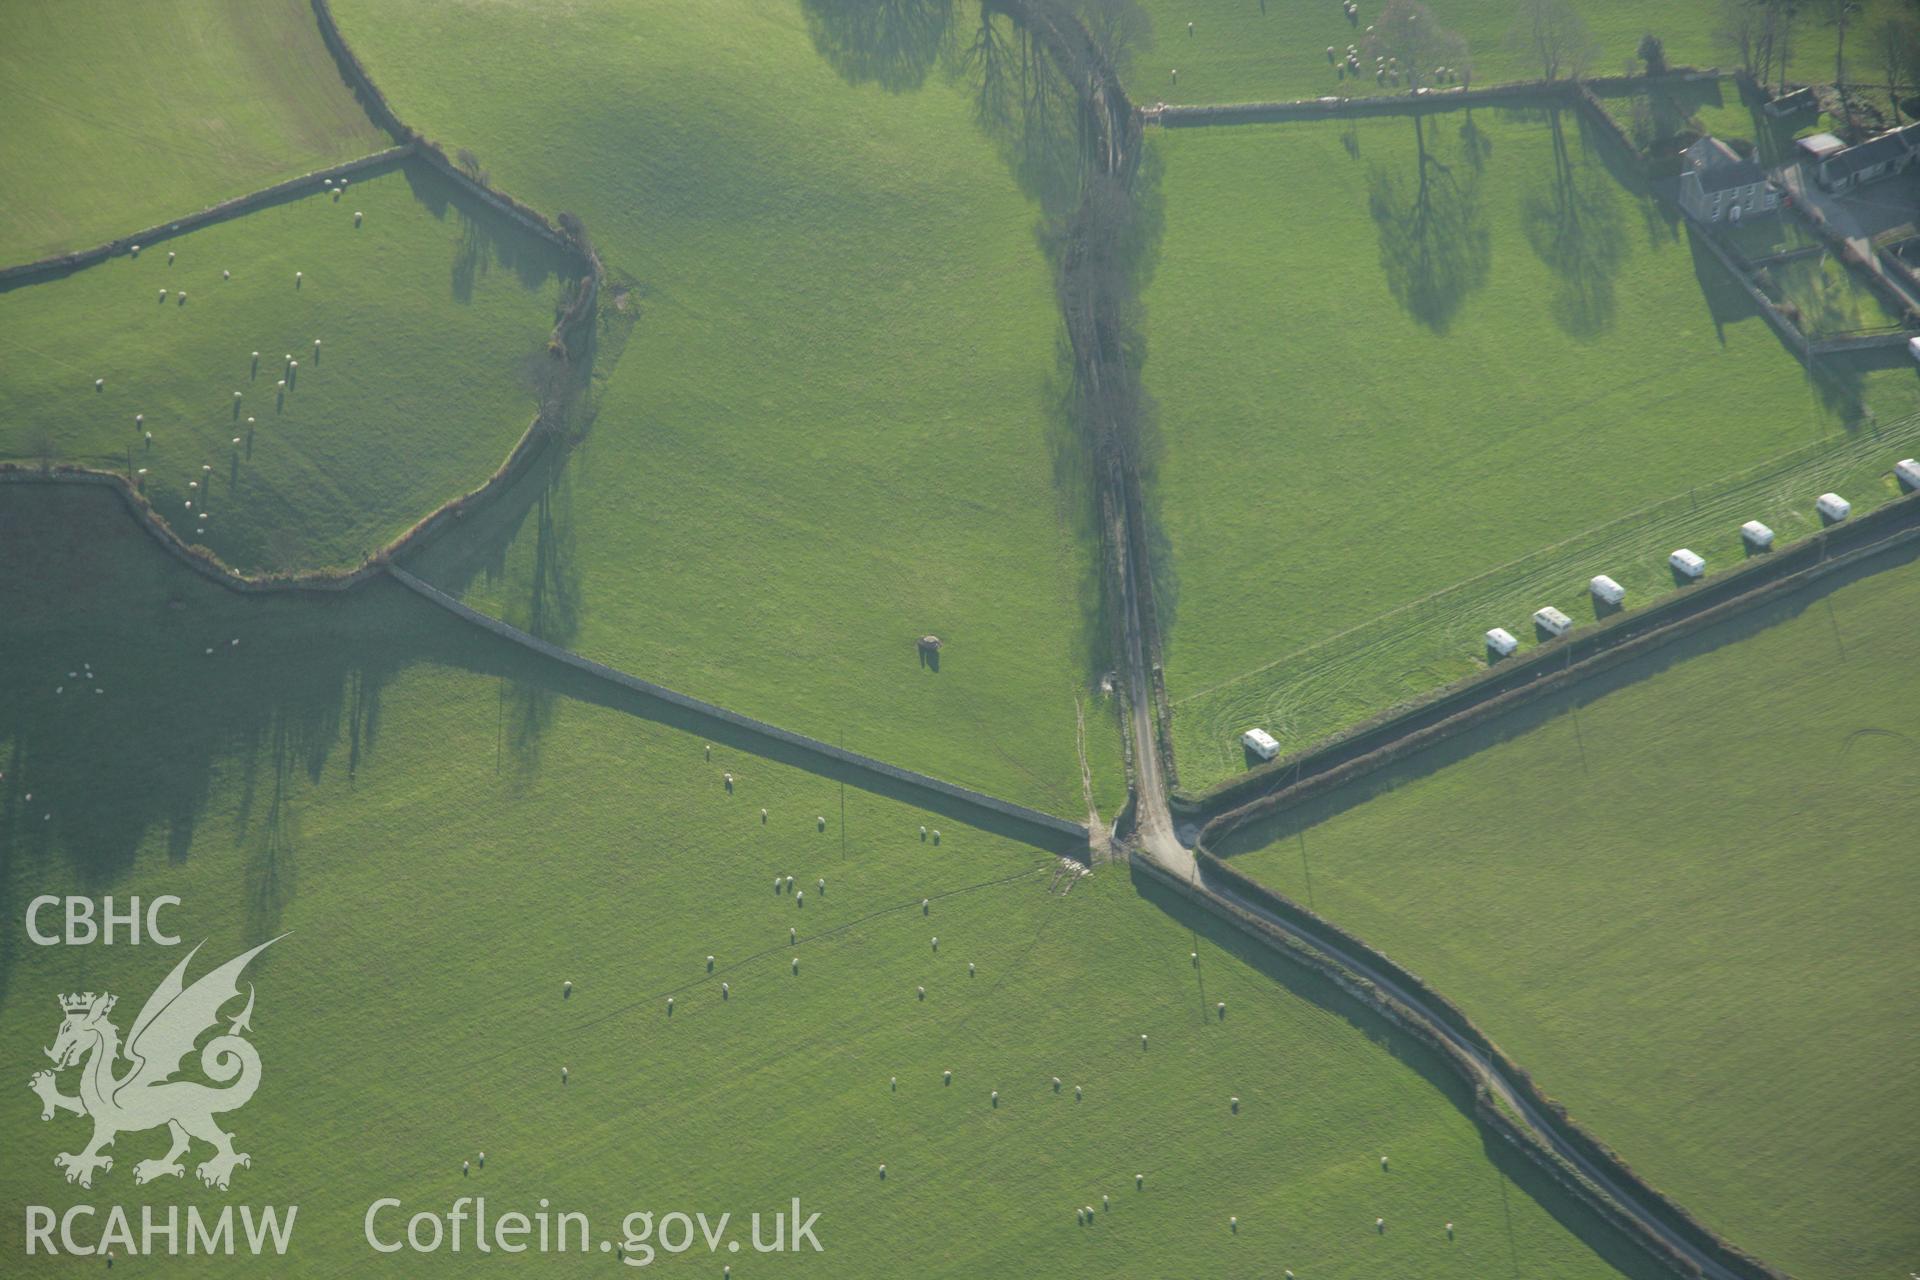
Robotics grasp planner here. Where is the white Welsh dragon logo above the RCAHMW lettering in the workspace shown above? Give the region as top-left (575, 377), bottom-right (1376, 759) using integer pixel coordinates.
top-left (29, 935), bottom-right (286, 1192)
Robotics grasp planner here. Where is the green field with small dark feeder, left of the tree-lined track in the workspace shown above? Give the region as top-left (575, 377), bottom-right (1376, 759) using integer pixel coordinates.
top-left (340, 0), bottom-right (1125, 816)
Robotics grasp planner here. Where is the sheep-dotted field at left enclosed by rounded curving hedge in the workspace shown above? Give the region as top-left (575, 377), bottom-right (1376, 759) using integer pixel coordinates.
top-left (0, 165), bottom-right (572, 570)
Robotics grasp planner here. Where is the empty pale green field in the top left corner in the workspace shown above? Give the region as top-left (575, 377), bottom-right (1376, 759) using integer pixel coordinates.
top-left (0, 0), bottom-right (392, 267)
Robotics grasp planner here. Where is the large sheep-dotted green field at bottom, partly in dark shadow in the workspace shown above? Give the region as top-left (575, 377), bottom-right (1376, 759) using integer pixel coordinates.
top-left (0, 486), bottom-right (1655, 1280)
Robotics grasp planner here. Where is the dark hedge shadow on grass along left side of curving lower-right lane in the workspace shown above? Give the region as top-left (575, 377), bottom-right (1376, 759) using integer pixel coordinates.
top-left (1133, 871), bottom-right (1668, 1280)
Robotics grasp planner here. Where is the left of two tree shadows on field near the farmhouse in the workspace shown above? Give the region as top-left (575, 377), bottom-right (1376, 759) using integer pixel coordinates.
top-left (1367, 113), bottom-right (1492, 334)
